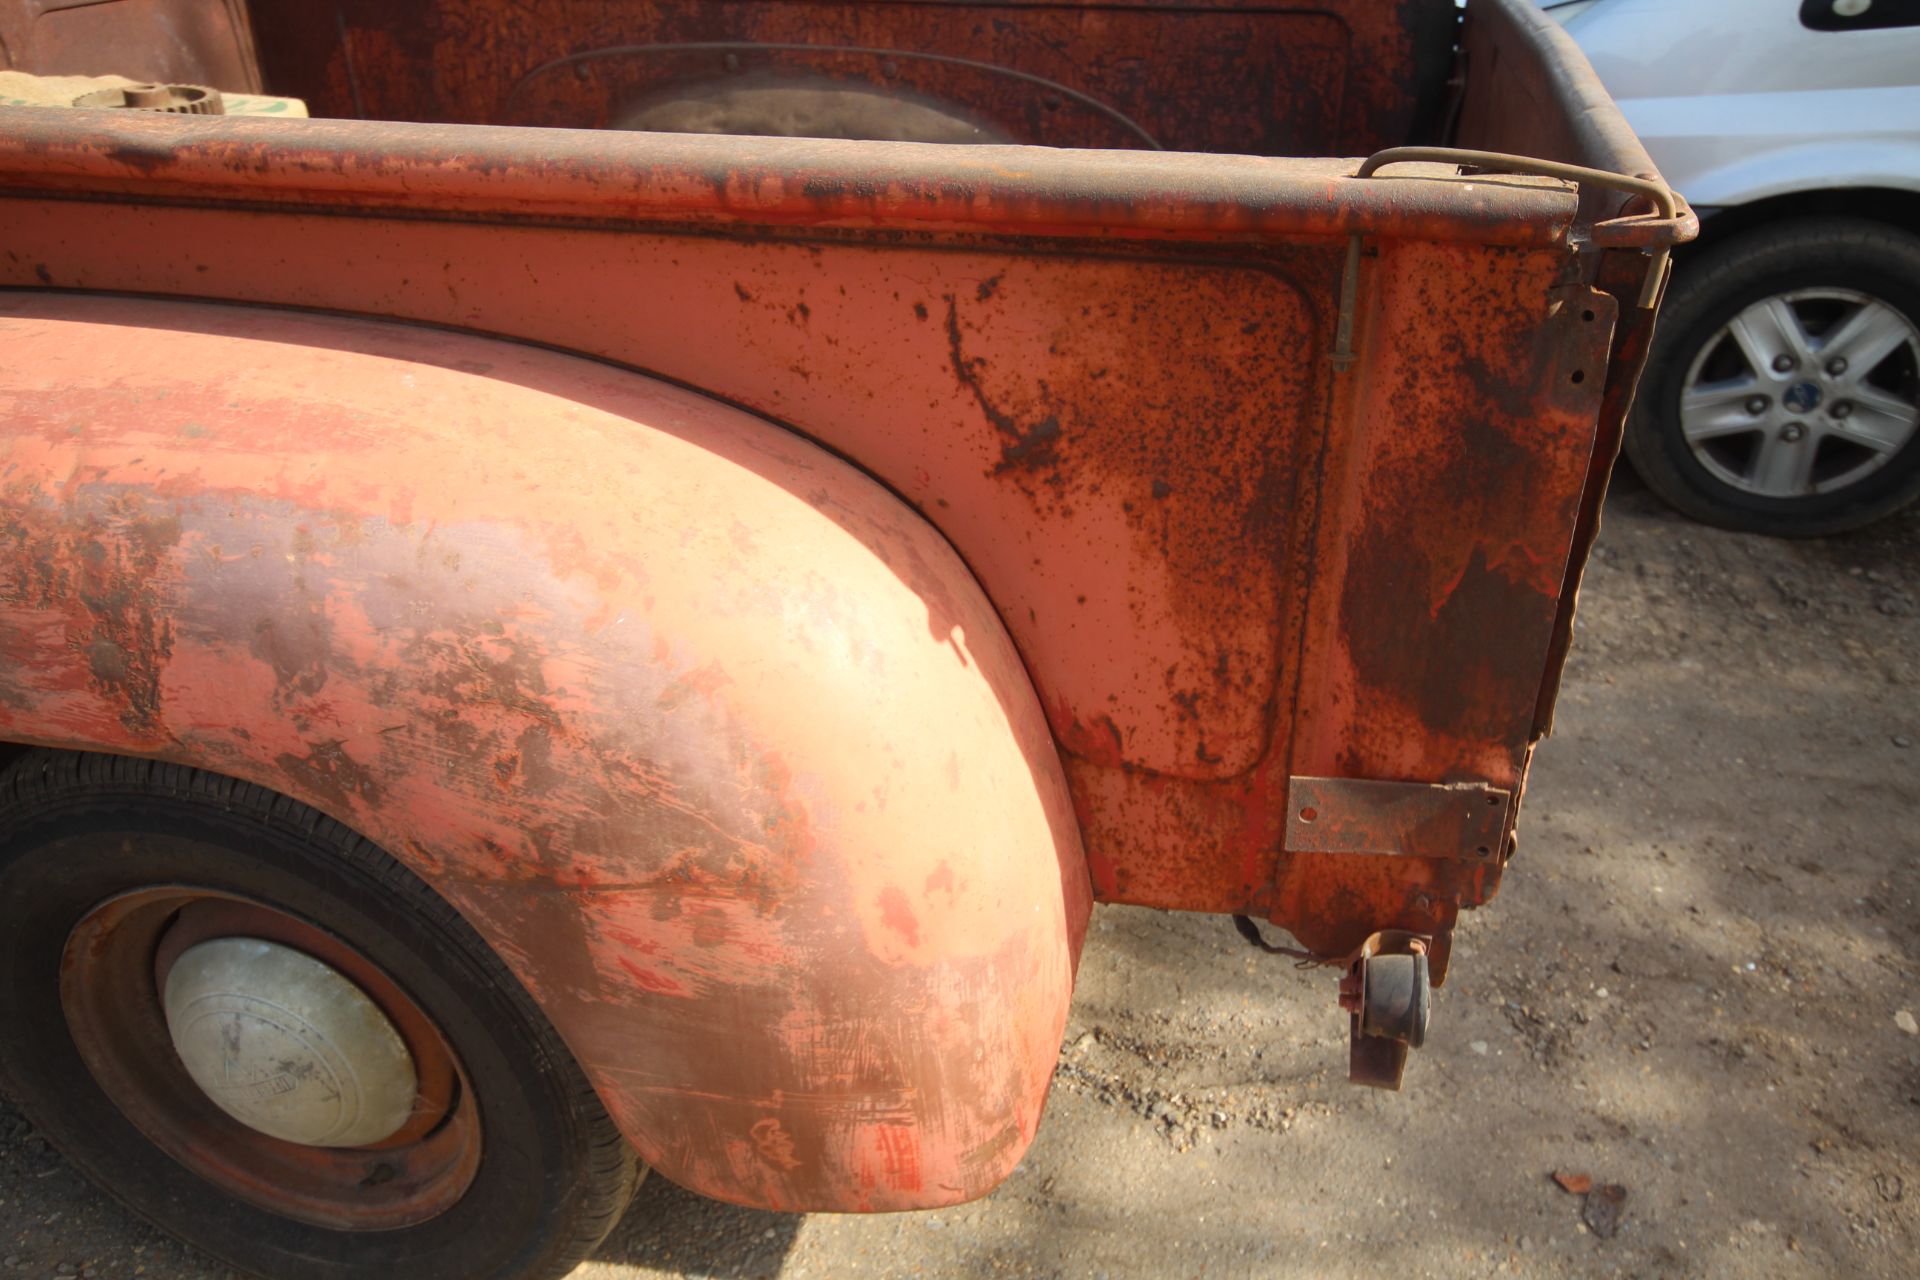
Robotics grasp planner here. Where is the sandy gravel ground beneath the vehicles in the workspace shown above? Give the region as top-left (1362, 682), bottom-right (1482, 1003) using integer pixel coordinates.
top-left (0, 478), bottom-right (1920, 1280)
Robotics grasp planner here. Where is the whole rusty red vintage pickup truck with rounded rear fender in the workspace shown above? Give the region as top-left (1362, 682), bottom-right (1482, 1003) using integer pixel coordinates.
top-left (0, 0), bottom-right (1695, 1278)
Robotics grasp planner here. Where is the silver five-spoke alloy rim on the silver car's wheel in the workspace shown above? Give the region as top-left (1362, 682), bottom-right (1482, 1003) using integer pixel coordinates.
top-left (1680, 290), bottom-right (1920, 497)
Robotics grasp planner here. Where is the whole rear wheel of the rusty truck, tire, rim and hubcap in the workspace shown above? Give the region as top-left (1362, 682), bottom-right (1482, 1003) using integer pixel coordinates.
top-left (0, 752), bottom-right (641, 1280)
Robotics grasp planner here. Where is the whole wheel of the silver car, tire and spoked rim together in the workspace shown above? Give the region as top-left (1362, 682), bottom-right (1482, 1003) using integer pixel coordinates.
top-left (1626, 217), bottom-right (1920, 537)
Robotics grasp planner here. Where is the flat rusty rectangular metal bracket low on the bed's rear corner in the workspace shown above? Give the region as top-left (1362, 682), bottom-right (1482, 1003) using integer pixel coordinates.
top-left (1286, 777), bottom-right (1513, 862)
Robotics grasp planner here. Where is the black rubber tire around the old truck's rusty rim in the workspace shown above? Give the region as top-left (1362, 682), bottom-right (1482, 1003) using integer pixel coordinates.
top-left (0, 750), bottom-right (643, 1280)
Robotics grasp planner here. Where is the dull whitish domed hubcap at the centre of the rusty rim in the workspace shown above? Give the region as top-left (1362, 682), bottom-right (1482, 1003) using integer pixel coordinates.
top-left (165, 938), bottom-right (419, 1148)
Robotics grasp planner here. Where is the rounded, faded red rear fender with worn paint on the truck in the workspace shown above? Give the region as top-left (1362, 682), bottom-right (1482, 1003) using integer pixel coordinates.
top-left (0, 294), bottom-right (1089, 1209)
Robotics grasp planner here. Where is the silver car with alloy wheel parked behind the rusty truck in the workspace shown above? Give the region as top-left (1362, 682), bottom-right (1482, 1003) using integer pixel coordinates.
top-left (1544, 0), bottom-right (1920, 535)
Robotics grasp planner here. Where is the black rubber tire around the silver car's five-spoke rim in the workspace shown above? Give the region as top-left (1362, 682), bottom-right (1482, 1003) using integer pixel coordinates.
top-left (1626, 217), bottom-right (1920, 537)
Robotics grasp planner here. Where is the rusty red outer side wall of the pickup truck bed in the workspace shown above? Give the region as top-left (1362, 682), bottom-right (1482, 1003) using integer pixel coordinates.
top-left (0, 100), bottom-right (1665, 940)
